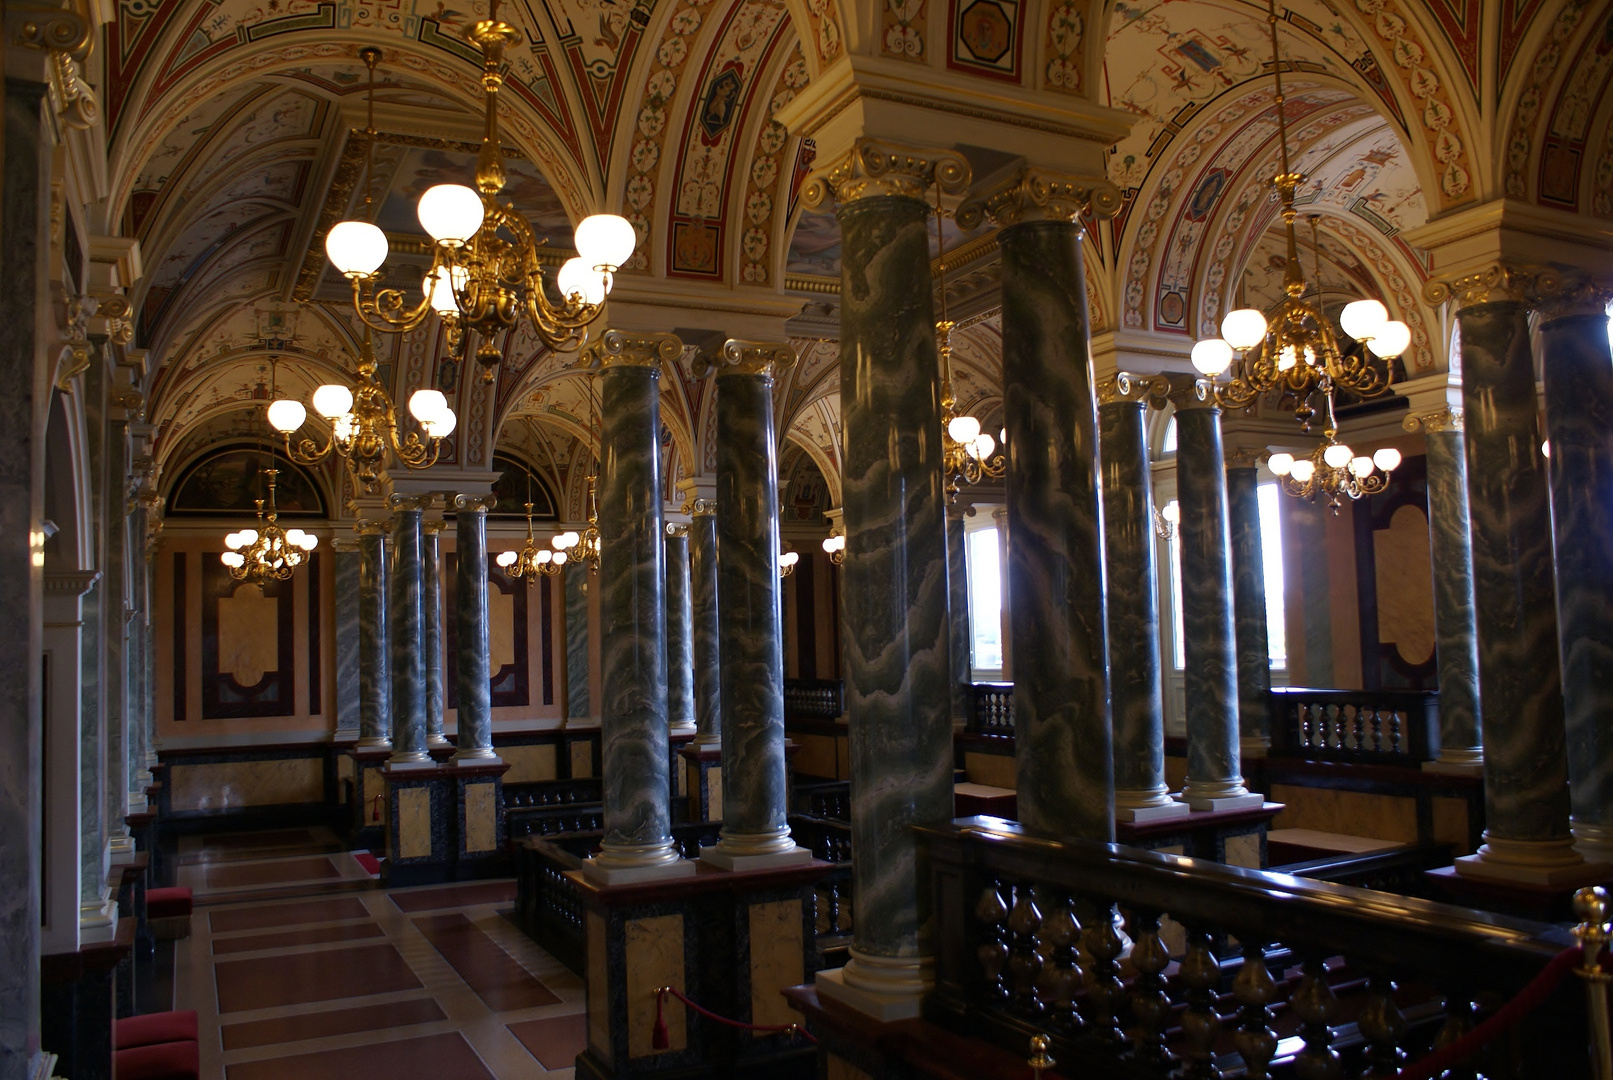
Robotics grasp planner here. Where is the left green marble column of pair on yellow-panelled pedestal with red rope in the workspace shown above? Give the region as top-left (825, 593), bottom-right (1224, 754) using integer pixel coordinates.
top-left (584, 330), bottom-right (695, 885)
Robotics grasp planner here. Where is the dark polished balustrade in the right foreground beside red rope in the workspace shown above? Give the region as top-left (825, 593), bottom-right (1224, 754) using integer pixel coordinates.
top-left (919, 819), bottom-right (1589, 1080)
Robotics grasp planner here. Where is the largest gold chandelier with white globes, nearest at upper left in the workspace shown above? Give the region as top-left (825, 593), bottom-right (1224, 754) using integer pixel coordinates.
top-left (324, 29), bottom-right (639, 382)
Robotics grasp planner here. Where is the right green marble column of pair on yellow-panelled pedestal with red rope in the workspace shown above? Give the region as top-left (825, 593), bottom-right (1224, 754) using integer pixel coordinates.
top-left (703, 342), bottom-right (811, 870)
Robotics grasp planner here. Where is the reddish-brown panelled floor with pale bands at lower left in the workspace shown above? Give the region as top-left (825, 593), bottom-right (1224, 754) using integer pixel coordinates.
top-left (174, 829), bottom-right (584, 1080)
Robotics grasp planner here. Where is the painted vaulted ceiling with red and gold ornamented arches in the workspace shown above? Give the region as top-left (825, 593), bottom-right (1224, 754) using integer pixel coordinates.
top-left (90, 0), bottom-right (1613, 519)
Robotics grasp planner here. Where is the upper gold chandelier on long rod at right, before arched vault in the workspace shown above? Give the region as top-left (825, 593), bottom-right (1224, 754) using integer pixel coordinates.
top-left (1192, 0), bottom-right (1411, 430)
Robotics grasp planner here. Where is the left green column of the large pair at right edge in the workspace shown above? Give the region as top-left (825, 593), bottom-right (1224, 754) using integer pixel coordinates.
top-left (1457, 291), bottom-right (1584, 883)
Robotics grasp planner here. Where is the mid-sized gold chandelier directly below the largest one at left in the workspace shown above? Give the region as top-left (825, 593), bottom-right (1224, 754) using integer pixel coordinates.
top-left (268, 327), bottom-right (458, 490)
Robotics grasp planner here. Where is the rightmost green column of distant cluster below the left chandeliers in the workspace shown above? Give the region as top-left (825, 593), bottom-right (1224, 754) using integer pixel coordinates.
top-left (453, 495), bottom-right (497, 764)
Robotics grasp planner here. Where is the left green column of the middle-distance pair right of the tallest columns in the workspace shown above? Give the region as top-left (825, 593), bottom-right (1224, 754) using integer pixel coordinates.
top-left (1098, 372), bottom-right (1189, 822)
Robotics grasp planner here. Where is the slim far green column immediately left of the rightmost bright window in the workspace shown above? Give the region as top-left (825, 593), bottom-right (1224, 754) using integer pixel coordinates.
top-left (1226, 450), bottom-right (1271, 758)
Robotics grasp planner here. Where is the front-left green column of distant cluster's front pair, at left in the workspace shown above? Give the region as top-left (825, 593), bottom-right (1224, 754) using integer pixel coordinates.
top-left (387, 495), bottom-right (431, 766)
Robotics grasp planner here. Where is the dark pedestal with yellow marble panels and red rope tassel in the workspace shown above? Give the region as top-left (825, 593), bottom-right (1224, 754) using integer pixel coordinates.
top-left (566, 862), bottom-right (829, 1080)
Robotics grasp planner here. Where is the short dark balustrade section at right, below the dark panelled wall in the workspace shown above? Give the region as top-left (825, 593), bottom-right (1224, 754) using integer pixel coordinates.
top-left (1271, 687), bottom-right (1439, 767)
